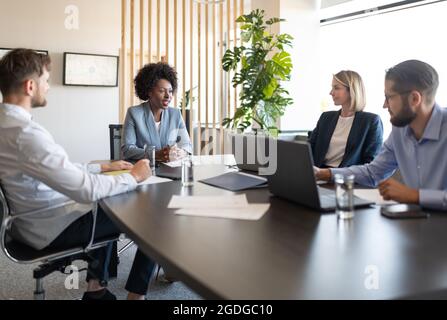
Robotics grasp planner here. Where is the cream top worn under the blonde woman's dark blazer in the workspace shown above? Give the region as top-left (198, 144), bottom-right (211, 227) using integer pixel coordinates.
top-left (325, 116), bottom-right (354, 168)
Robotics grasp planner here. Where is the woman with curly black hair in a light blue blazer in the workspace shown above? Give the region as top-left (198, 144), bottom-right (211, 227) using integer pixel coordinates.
top-left (121, 62), bottom-right (192, 162)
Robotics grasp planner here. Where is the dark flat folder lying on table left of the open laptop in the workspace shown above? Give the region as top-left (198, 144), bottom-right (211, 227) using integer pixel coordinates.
top-left (200, 172), bottom-right (268, 191)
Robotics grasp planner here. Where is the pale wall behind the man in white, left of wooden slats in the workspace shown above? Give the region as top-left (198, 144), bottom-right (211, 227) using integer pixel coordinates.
top-left (0, 0), bottom-right (121, 162)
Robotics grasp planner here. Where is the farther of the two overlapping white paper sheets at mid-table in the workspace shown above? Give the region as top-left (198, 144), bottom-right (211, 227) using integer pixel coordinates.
top-left (168, 194), bottom-right (248, 210)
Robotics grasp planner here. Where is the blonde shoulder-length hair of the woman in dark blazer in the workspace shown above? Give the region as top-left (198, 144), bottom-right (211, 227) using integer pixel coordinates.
top-left (334, 70), bottom-right (366, 112)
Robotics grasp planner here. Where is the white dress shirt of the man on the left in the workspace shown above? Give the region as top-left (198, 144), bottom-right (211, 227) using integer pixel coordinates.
top-left (0, 104), bottom-right (137, 250)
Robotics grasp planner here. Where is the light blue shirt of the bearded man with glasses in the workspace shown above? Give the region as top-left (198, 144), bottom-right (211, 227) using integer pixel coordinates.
top-left (331, 104), bottom-right (447, 210)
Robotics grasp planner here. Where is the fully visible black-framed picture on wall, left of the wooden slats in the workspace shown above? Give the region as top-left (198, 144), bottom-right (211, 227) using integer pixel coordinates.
top-left (63, 52), bottom-right (119, 87)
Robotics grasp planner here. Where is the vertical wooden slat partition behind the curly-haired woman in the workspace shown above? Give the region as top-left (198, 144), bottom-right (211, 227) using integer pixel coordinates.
top-left (119, 0), bottom-right (244, 154)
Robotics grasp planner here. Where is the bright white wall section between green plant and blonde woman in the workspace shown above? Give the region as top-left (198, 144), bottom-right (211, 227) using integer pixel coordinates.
top-left (251, 0), bottom-right (321, 130)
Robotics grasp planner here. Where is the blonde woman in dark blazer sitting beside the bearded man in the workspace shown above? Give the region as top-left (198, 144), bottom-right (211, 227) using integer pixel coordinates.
top-left (309, 70), bottom-right (383, 168)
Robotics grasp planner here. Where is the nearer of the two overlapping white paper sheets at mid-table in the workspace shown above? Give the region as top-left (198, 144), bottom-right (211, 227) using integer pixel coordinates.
top-left (174, 203), bottom-right (270, 220)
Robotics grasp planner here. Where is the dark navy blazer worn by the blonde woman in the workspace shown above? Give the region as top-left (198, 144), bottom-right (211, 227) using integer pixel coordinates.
top-left (309, 110), bottom-right (383, 168)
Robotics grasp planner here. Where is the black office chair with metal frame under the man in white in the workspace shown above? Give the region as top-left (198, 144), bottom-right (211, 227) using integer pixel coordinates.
top-left (0, 185), bottom-right (119, 300)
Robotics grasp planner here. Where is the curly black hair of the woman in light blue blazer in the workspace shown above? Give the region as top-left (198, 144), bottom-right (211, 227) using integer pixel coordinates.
top-left (134, 62), bottom-right (178, 101)
